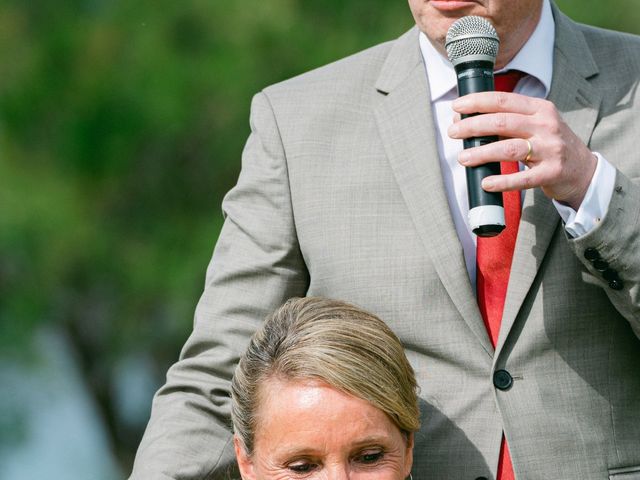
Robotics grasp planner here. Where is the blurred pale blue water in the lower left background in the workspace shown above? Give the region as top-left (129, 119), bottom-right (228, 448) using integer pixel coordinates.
top-left (0, 331), bottom-right (122, 480)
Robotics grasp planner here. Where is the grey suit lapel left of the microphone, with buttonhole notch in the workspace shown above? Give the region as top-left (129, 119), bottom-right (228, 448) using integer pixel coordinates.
top-left (375, 28), bottom-right (493, 355)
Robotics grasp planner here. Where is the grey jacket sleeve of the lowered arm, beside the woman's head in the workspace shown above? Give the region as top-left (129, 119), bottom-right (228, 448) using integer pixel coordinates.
top-left (130, 93), bottom-right (308, 480)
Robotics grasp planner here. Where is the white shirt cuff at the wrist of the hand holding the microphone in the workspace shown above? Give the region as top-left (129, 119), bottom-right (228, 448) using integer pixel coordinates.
top-left (553, 152), bottom-right (616, 238)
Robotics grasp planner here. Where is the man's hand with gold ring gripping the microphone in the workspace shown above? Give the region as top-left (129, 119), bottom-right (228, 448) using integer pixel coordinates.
top-left (449, 92), bottom-right (597, 210)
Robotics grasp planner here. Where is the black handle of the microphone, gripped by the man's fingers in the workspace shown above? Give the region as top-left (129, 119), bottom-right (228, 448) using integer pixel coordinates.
top-left (455, 61), bottom-right (505, 237)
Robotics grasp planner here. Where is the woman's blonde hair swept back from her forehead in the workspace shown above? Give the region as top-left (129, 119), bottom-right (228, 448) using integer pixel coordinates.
top-left (231, 297), bottom-right (420, 455)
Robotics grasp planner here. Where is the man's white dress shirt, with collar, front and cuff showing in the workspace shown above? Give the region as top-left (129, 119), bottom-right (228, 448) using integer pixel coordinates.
top-left (420, 0), bottom-right (616, 285)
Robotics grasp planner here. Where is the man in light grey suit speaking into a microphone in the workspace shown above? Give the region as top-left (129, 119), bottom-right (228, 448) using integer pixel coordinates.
top-left (132, 0), bottom-right (640, 480)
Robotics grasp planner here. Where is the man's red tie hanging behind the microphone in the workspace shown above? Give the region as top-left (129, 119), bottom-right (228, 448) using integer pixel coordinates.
top-left (476, 70), bottom-right (523, 480)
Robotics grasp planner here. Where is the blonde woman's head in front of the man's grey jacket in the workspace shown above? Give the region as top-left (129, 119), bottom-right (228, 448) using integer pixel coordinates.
top-left (232, 298), bottom-right (419, 478)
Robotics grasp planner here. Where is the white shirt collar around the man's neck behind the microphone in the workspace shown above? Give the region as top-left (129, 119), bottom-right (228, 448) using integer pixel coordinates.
top-left (419, 0), bottom-right (555, 101)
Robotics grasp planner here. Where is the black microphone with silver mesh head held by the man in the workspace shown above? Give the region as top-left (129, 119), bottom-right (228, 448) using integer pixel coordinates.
top-left (445, 16), bottom-right (505, 237)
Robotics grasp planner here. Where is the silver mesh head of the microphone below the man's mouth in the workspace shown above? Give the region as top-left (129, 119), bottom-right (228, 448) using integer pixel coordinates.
top-left (445, 15), bottom-right (500, 65)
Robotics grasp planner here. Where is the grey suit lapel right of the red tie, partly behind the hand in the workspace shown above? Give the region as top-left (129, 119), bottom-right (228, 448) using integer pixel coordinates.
top-left (497, 6), bottom-right (602, 350)
